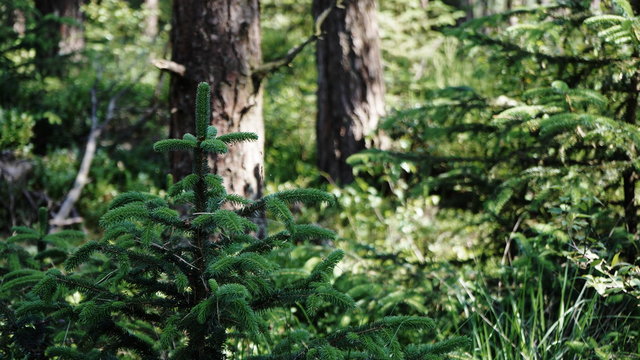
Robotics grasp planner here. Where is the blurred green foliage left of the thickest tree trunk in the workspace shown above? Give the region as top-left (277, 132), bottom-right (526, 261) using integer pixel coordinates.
top-left (0, 0), bottom-right (168, 236)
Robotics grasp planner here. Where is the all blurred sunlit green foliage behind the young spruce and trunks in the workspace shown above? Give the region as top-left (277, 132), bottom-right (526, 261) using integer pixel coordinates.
top-left (0, 0), bottom-right (640, 360)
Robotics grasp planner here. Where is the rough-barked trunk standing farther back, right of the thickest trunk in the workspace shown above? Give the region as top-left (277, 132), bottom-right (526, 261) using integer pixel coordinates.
top-left (313, 0), bottom-right (384, 184)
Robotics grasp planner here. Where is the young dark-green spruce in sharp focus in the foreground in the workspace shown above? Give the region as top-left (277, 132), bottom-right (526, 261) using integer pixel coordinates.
top-left (8, 83), bottom-right (467, 360)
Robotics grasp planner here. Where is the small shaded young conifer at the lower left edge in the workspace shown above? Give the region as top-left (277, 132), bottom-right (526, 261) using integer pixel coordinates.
top-left (0, 208), bottom-right (85, 359)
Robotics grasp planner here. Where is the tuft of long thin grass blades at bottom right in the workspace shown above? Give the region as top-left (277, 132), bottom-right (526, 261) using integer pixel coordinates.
top-left (459, 266), bottom-right (640, 360)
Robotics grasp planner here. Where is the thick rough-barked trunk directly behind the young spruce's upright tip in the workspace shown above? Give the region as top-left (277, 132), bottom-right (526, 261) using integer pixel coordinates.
top-left (169, 0), bottom-right (264, 199)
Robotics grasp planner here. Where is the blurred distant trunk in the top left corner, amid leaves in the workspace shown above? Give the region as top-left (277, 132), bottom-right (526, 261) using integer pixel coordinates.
top-left (35, 0), bottom-right (84, 58)
